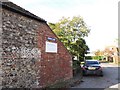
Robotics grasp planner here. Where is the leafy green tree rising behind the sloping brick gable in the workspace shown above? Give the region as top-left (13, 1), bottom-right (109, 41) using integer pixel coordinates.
top-left (49, 16), bottom-right (90, 60)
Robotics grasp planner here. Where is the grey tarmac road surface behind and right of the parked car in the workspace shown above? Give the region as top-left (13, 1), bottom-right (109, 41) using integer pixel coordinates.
top-left (73, 63), bottom-right (120, 89)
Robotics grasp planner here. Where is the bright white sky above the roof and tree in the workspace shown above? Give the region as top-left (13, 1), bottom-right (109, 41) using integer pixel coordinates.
top-left (9, 0), bottom-right (119, 52)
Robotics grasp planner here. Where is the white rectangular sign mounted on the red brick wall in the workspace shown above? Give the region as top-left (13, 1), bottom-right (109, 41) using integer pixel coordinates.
top-left (46, 41), bottom-right (57, 53)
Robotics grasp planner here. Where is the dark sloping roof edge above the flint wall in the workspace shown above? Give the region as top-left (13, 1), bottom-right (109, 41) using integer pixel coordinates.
top-left (0, 1), bottom-right (46, 22)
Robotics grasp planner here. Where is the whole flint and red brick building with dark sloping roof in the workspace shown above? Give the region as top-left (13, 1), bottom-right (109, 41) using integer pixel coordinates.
top-left (0, 2), bottom-right (73, 88)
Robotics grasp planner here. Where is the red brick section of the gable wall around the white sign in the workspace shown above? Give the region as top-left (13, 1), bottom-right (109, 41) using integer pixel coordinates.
top-left (37, 24), bottom-right (72, 86)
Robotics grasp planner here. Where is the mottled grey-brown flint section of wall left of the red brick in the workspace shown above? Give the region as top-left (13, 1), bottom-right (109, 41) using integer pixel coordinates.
top-left (2, 9), bottom-right (41, 88)
